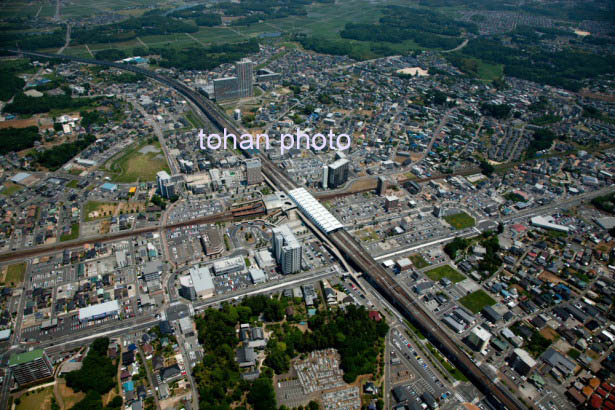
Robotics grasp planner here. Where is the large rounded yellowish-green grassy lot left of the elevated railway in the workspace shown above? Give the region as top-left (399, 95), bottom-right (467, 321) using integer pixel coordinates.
top-left (108, 141), bottom-right (169, 183)
